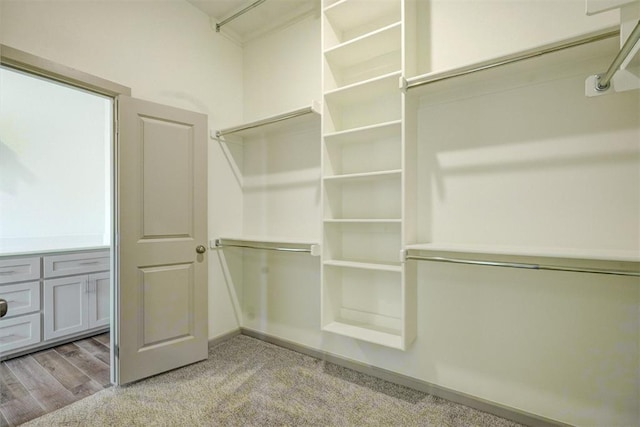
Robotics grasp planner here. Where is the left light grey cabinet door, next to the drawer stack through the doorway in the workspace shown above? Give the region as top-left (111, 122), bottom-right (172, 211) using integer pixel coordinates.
top-left (44, 275), bottom-right (89, 340)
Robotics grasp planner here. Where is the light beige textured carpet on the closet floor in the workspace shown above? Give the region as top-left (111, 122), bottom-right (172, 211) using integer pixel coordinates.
top-left (25, 335), bottom-right (518, 427)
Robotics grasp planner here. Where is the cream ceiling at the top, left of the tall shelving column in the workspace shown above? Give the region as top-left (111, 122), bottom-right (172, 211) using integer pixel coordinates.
top-left (187, 0), bottom-right (320, 43)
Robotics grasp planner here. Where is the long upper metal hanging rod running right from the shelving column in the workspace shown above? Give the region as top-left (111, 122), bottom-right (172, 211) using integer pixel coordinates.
top-left (402, 29), bottom-right (620, 92)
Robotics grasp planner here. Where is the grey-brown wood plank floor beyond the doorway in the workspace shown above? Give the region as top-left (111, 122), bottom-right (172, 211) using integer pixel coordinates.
top-left (0, 333), bottom-right (111, 427)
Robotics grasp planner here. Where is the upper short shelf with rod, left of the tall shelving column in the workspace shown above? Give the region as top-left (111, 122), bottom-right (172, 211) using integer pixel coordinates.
top-left (211, 101), bottom-right (320, 138)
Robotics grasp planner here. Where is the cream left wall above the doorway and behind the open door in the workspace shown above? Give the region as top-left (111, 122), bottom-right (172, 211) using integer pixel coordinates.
top-left (0, 0), bottom-right (242, 337)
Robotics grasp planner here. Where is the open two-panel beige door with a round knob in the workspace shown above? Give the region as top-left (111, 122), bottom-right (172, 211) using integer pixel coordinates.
top-left (112, 96), bottom-right (208, 384)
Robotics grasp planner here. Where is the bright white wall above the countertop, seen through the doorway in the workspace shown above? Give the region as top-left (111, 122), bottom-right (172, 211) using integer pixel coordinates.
top-left (0, 69), bottom-right (113, 254)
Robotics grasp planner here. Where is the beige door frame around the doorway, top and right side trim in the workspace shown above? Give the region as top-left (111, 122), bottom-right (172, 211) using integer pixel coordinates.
top-left (0, 44), bottom-right (131, 384)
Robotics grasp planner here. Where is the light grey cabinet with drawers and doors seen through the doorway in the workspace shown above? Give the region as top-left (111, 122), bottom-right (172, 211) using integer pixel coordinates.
top-left (0, 250), bottom-right (110, 357)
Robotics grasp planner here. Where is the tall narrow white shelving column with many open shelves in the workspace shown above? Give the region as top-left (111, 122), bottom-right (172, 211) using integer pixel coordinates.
top-left (322, 0), bottom-right (415, 349)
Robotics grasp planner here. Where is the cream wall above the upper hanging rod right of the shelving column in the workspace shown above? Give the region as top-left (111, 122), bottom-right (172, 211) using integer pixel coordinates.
top-left (418, 0), bottom-right (619, 73)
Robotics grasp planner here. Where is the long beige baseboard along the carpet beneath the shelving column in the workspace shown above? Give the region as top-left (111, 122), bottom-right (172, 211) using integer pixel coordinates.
top-left (239, 328), bottom-right (570, 427)
